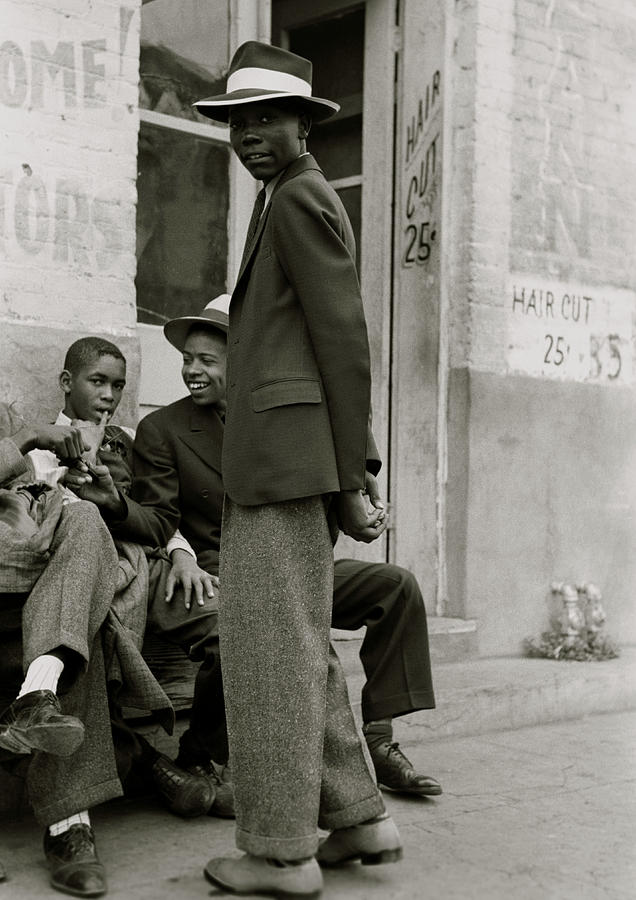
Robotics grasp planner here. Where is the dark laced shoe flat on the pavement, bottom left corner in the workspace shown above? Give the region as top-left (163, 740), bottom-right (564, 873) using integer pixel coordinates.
top-left (44, 825), bottom-right (108, 897)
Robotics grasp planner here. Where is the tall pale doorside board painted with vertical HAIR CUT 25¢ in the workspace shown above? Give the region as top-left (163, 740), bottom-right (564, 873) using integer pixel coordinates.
top-left (389, 0), bottom-right (446, 614)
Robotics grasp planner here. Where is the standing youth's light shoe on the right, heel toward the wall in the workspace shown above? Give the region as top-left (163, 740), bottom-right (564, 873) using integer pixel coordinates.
top-left (316, 813), bottom-right (402, 866)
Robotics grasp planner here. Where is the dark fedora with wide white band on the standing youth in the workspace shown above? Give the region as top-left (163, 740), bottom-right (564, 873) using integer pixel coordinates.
top-left (194, 41), bottom-right (340, 122)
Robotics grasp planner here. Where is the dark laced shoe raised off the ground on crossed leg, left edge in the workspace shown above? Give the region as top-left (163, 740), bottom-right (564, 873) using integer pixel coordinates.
top-left (0, 691), bottom-right (84, 756)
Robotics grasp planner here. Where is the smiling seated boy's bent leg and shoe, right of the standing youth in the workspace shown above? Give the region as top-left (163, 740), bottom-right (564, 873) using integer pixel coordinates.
top-left (333, 559), bottom-right (442, 796)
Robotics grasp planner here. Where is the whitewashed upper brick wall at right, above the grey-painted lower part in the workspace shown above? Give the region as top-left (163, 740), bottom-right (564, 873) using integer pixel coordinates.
top-left (453, 0), bottom-right (636, 376)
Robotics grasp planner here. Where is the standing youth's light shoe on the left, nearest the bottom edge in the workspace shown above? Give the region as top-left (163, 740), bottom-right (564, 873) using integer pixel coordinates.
top-left (203, 853), bottom-right (323, 898)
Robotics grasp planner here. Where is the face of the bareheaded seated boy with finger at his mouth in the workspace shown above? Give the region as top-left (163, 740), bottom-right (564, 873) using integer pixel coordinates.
top-left (60, 356), bottom-right (126, 422)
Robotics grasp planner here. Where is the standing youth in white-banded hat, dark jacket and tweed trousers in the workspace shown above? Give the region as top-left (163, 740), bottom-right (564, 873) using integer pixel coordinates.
top-left (196, 41), bottom-right (401, 896)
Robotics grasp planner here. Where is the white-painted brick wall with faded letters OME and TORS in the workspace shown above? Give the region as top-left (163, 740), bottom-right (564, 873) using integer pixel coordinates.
top-left (0, 0), bottom-right (141, 420)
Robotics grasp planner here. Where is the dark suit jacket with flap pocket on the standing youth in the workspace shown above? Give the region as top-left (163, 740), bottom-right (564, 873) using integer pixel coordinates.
top-left (223, 156), bottom-right (379, 506)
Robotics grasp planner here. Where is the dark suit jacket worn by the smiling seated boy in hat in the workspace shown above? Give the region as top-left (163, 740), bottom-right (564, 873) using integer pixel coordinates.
top-left (113, 397), bottom-right (223, 573)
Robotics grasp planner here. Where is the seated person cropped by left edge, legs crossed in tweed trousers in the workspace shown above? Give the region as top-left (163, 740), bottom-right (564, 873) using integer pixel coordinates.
top-left (0, 405), bottom-right (122, 896)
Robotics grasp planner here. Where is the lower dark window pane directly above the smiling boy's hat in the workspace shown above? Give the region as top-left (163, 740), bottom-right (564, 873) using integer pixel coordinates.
top-left (136, 122), bottom-right (229, 325)
